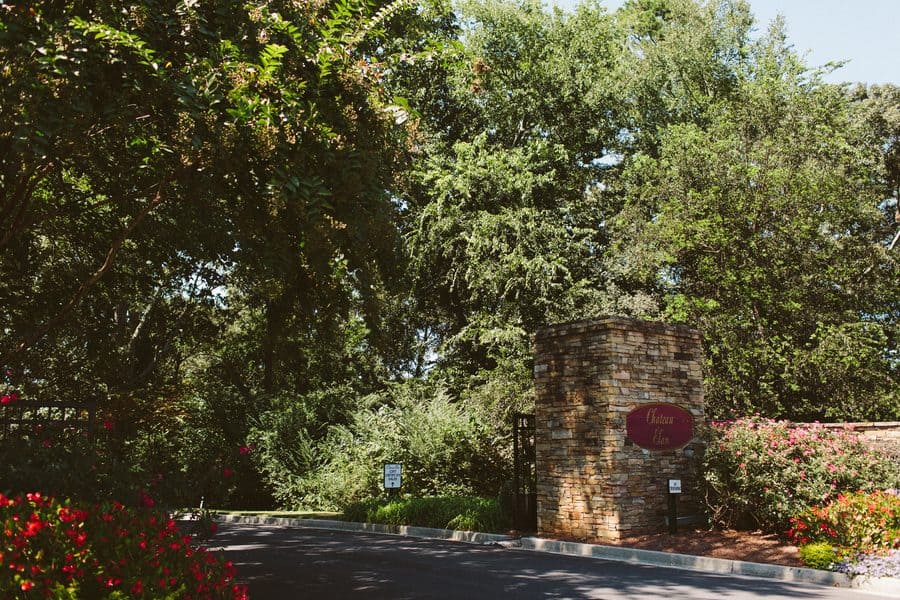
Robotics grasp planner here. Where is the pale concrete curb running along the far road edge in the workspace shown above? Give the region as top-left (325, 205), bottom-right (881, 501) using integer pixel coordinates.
top-left (216, 515), bottom-right (900, 598)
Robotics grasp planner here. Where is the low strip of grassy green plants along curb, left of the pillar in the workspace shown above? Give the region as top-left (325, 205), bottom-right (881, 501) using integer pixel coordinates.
top-left (344, 496), bottom-right (510, 532)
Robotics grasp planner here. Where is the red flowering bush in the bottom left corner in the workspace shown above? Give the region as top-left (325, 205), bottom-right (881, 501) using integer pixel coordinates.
top-left (0, 493), bottom-right (247, 600)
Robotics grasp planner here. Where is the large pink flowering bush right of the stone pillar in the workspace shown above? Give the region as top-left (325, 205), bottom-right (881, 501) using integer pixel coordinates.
top-left (703, 418), bottom-right (900, 533)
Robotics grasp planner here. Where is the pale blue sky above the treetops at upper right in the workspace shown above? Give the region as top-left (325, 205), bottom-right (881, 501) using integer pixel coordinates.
top-left (551, 0), bottom-right (900, 85)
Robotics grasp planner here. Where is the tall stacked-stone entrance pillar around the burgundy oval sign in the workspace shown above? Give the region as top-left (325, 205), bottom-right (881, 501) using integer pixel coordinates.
top-left (534, 318), bottom-right (704, 540)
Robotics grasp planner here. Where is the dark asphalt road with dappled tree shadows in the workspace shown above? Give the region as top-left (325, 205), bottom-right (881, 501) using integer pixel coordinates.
top-left (209, 524), bottom-right (878, 600)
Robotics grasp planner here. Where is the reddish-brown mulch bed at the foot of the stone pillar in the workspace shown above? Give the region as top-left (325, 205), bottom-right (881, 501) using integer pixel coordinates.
top-left (594, 530), bottom-right (803, 567)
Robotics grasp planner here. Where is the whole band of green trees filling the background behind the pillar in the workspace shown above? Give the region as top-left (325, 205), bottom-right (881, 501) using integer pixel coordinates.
top-left (0, 0), bottom-right (900, 503)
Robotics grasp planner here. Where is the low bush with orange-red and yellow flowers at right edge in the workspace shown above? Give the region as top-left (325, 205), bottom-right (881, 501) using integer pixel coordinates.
top-left (788, 491), bottom-right (900, 553)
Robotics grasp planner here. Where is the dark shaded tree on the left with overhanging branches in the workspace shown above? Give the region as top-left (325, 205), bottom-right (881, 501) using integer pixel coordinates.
top-left (0, 0), bottom-right (412, 398)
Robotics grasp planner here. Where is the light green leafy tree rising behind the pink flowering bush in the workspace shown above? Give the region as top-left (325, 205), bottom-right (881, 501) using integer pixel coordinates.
top-left (615, 24), bottom-right (900, 420)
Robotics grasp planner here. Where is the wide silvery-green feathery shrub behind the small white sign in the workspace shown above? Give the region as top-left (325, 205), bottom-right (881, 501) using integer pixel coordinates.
top-left (251, 382), bottom-right (511, 510)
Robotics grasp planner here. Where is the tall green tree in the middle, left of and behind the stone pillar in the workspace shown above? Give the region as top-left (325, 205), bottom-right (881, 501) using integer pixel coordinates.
top-left (400, 1), bottom-right (619, 386)
